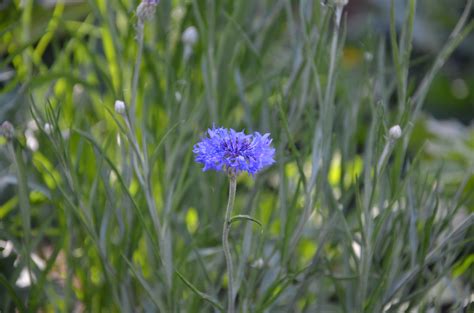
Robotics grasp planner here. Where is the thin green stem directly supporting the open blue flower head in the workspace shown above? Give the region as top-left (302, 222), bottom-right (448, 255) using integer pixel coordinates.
top-left (222, 174), bottom-right (237, 313)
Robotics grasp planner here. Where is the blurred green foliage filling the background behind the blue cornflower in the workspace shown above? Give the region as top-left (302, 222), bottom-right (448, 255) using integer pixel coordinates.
top-left (0, 0), bottom-right (474, 312)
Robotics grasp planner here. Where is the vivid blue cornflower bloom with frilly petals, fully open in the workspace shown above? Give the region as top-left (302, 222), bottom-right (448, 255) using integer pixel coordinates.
top-left (193, 127), bottom-right (275, 175)
